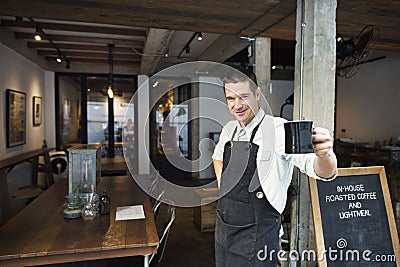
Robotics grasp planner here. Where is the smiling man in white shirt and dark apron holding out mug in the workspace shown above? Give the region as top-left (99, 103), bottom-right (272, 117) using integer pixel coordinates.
top-left (213, 71), bottom-right (337, 267)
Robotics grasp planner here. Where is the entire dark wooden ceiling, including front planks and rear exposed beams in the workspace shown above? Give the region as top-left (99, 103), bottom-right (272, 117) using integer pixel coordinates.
top-left (0, 0), bottom-right (400, 74)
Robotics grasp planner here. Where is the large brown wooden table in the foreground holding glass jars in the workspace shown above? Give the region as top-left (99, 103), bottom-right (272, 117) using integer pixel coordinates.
top-left (0, 176), bottom-right (159, 266)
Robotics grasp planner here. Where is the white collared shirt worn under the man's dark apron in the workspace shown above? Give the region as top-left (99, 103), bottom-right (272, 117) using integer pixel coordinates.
top-left (212, 108), bottom-right (336, 213)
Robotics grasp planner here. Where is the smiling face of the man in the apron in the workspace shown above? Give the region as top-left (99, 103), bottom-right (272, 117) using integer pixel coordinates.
top-left (225, 81), bottom-right (261, 127)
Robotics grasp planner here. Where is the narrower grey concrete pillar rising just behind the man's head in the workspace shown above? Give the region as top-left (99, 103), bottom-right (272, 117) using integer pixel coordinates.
top-left (254, 37), bottom-right (271, 100)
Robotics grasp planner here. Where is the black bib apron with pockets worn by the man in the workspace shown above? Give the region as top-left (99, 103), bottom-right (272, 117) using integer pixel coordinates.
top-left (215, 120), bottom-right (281, 267)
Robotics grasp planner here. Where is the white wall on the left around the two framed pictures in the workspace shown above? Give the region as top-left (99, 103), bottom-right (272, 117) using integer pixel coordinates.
top-left (0, 44), bottom-right (46, 160)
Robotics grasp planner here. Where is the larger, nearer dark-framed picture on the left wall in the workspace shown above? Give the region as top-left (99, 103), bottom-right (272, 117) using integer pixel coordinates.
top-left (6, 89), bottom-right (26, 147)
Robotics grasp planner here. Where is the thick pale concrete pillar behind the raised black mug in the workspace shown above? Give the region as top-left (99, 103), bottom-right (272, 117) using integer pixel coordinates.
top-left (291, 0), bottom-right (337, 266)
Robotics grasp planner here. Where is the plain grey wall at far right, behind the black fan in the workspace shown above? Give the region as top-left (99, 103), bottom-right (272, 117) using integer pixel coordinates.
top-left (336, 51), bottom-right (400, 143)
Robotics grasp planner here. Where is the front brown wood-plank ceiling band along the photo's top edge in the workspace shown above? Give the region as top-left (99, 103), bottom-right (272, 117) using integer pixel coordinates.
top-left (0, 0), bottom-right (400, 53)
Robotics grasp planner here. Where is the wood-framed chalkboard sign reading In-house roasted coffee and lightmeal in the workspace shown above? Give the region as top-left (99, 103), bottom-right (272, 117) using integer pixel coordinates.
top-left (309, 167), bottom-right (400, 267)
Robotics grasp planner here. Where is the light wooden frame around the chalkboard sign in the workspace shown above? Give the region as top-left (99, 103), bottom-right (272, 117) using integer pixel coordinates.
top-left (308, 166), bottom-right (400, 267)
